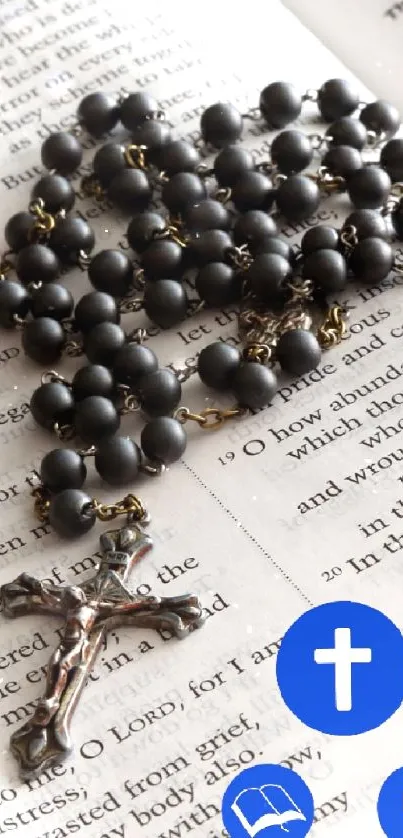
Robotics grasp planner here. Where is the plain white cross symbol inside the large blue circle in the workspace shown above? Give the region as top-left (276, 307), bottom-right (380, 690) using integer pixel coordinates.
top-left (313, 628), bottom-right (372, 711)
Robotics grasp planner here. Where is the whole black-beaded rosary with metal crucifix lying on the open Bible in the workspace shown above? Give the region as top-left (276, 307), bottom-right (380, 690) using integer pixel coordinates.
top-left (0, 79), bottom-right (403, 777)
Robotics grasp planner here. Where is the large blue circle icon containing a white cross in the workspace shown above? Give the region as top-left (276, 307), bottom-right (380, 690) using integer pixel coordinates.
top-left (277, 602), bottom-right (403, 736)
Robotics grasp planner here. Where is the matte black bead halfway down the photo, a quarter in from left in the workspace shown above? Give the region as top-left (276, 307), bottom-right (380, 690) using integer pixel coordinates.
top-left (74, 396), bottom-right (120, 445)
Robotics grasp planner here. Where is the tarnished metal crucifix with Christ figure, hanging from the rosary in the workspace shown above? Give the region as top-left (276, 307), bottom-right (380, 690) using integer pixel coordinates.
top-left (0, 524), bottom-right (203, 778)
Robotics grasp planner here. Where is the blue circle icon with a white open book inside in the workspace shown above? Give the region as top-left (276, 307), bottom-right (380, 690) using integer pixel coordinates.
top-left (221, 764), bottom-right (314, 838)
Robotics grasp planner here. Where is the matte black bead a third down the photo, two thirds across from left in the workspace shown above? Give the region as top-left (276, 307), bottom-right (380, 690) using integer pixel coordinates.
top-left (246, 253), bottom-right (292, 305)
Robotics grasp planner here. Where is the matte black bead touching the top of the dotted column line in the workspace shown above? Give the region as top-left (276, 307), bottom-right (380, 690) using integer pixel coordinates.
top-left (141, 416), bottom-right (187, 466)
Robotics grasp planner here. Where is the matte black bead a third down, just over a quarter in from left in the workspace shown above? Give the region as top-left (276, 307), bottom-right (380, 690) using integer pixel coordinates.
top-left (88, 250), bottom-right (133, 297)
